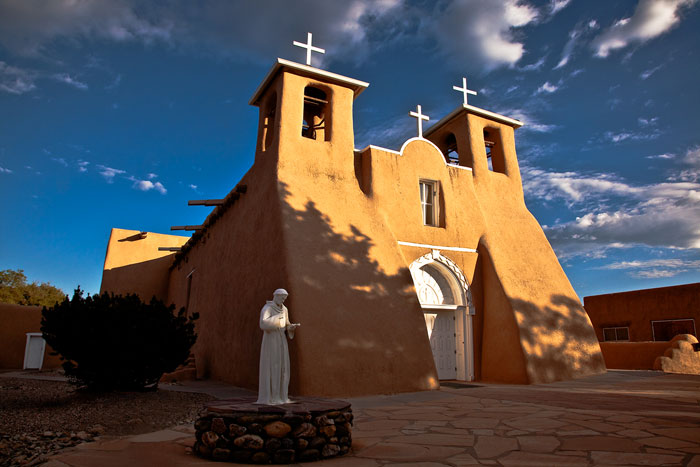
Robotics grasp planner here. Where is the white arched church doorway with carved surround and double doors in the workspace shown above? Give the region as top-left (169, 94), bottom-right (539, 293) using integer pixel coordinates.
top-left (410, 250), bottom-right (474, 381)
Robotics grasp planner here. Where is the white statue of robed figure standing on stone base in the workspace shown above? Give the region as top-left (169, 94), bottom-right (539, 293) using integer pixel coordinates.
top-left (256, 289), bottom-right (300, 405)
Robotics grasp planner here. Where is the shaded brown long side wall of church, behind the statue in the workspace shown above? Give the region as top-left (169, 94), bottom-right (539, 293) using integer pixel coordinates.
top-left (168, 154), bottom-right (290, 390)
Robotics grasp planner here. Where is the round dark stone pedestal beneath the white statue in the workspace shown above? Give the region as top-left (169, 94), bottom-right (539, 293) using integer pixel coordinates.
top-left (193, 397), bottom-right (353, 464)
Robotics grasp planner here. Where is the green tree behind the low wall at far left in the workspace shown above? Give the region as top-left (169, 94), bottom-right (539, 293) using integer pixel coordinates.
top-left (0, 269), bottom-right (66, 306)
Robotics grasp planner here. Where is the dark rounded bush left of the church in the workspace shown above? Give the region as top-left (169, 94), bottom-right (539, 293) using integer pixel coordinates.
top-left (41, 287), bottom-right (198, 391)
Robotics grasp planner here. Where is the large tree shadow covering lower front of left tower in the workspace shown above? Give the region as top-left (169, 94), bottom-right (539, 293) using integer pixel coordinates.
top-left (279, 182), bottom-right (438, 395)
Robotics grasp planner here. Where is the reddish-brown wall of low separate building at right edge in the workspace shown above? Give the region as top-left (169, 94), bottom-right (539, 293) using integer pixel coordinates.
top-left (583, 283), bottom-right (700, 342)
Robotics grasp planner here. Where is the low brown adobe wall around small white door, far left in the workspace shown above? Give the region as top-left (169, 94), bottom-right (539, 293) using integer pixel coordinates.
top-left (0, 303), bottom-right (61, 369)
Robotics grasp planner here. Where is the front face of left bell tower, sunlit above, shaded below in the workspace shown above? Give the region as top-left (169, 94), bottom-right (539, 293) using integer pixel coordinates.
top-left (278, 74), bottom-right (438, 397)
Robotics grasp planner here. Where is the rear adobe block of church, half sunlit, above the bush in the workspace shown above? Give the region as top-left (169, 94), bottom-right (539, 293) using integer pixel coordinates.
top-left (100, 229), bottom-right (189, 302)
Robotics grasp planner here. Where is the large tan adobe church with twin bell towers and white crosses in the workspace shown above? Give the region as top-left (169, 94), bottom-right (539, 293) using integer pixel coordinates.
top-left (101, 41), bottom-right (605, 397)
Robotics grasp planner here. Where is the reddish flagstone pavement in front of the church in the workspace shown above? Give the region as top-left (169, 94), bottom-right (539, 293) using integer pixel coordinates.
top-left (44, 370), bottom-right (700, 467)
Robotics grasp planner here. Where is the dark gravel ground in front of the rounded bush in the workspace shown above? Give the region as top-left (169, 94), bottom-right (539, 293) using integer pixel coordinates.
top-left (0, 378), bottom-right (213, 466)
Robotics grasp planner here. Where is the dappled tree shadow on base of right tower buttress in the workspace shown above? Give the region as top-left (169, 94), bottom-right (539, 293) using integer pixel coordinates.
top-left (511, 294), bottom-right (605, 383)
